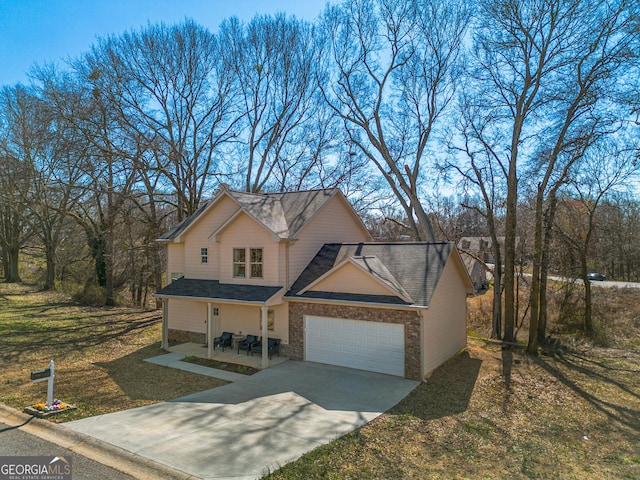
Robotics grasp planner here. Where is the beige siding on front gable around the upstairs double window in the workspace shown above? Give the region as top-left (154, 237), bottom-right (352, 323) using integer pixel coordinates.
top-left (218, 213), bottom-right (280, 286)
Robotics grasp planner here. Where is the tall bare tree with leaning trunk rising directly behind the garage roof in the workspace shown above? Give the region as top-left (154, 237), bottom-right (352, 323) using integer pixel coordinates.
top-left (321, 0), bottom-right (469, 241)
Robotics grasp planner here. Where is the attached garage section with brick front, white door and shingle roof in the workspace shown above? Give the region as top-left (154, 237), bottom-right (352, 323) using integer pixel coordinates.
top-left (283, 242), bottom-right (474, 380)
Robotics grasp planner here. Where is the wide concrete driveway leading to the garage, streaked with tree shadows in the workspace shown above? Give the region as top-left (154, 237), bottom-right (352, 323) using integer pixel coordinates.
top-left (65, 361), bottom-right (418, 479)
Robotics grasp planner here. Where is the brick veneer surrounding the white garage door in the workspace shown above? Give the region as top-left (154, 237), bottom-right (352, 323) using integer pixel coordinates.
top-left (286, 302), bottom-right (421, 380)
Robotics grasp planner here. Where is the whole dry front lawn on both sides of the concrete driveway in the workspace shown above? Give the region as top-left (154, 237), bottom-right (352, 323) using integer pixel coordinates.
top-left (0, 283), bottom-right (640, 480)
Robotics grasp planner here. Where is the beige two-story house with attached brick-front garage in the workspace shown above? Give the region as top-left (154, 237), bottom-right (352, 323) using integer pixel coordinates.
top-left (156, 189), bottom-right (473, 379)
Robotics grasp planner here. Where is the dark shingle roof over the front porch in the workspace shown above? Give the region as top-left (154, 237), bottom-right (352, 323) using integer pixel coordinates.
top-left (155, 278), bottom-right (283, 303)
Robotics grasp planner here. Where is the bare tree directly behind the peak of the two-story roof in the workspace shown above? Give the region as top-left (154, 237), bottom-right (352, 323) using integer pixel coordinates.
top-left (220, 14), bottom-right (324, 192)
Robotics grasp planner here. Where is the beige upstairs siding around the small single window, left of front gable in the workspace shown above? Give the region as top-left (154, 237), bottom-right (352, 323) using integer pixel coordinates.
top-left (183, 196), bottom-right (239, 280)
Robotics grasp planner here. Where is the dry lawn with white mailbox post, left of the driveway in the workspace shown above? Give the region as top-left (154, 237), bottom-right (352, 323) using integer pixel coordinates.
top-left (0, 283), bottom-right (226, 422)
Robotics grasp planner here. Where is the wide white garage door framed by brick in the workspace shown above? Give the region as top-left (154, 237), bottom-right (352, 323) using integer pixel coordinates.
top-left (304, 316), bottom-right (404, 377)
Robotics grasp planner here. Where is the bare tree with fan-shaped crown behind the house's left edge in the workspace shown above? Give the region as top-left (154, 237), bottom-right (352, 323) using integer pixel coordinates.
top-left (83, 21), bottom-right (238, 220)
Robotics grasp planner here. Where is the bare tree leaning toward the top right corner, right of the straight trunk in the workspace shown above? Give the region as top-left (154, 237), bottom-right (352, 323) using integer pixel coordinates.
top-left (527, 1), bottom-right (638, 353)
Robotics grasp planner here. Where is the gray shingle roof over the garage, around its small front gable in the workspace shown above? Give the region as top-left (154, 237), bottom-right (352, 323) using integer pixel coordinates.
top-left (286, 242), bottom-right (455, 306)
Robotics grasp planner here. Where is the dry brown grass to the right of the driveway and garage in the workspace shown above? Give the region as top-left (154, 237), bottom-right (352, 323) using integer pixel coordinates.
top-left (269, 340), bottom-right (640, 479)
